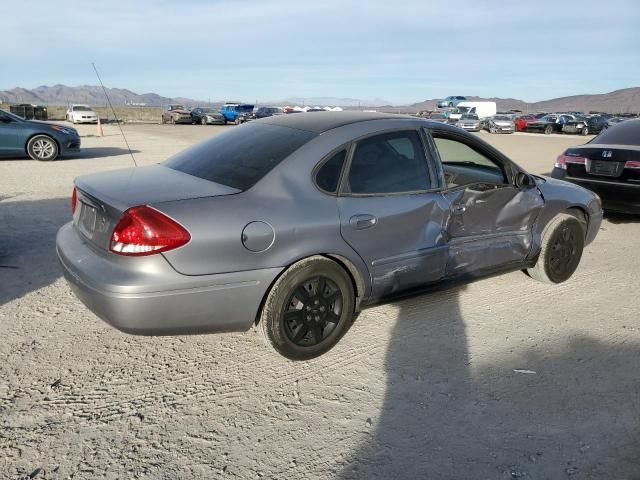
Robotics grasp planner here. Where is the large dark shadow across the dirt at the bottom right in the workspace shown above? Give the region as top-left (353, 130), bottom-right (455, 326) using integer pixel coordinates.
top-left (338, 287), bottom-right (640, 480)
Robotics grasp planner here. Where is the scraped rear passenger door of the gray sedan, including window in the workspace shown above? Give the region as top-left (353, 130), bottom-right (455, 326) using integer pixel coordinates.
top-left (338, 129), bottom-right (449, 298)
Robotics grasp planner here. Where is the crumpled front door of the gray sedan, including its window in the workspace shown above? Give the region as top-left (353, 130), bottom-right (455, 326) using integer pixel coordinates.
top-left (432, 130), bottom-right (544, 276)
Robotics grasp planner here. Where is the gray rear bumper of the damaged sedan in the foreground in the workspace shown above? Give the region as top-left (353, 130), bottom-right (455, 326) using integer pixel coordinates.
top-left (56, 223), bottom-right (282, 335)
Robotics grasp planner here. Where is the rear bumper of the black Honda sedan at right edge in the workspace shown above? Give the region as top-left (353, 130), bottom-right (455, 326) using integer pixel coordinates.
top-left (551, 168), bottom-right (640, 215)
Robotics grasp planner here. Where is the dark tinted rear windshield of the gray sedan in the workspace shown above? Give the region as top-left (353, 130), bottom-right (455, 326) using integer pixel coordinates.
top-left (164, 123), bottom-right (315, 190)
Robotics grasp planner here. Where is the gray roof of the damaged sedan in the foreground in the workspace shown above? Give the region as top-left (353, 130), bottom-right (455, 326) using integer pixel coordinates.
top-left (258, 112), bottom-right (415, 134)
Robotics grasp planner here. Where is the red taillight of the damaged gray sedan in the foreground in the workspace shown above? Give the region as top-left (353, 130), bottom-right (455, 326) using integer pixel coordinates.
top-left (109, 205), bottom-right (191, 256)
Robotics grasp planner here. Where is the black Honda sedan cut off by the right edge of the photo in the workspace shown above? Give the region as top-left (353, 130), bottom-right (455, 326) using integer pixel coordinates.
top-left (551, 119), bottom-right (640, 214)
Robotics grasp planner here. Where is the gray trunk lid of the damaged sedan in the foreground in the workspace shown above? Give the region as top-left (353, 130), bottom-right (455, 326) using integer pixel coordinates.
top-left (73, 165), bottom-right (240, 250)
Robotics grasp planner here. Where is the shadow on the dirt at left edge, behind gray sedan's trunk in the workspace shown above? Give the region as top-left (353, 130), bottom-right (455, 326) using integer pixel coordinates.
top-left (0, 198), bottom-right (71, 306)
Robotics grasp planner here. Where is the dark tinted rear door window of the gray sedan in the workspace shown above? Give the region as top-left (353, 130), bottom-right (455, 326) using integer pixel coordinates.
top-left (346, 130), bottom-right (433, 195)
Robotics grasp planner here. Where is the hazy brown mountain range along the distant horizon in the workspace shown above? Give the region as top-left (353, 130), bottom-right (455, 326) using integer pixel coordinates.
top-left (0, 85), bottom-right (640, 113)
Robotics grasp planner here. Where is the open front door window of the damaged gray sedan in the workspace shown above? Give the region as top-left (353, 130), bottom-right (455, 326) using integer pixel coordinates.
top-left (433, 136), bottom-right (506, 189)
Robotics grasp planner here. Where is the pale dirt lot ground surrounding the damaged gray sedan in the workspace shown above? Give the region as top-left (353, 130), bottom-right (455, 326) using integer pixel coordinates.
top-left (0, 125), bottom-right (640, 480)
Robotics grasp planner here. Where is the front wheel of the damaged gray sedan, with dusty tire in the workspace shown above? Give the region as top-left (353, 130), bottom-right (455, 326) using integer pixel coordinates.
top-left (527, 213), bottom-right (585, 283)
